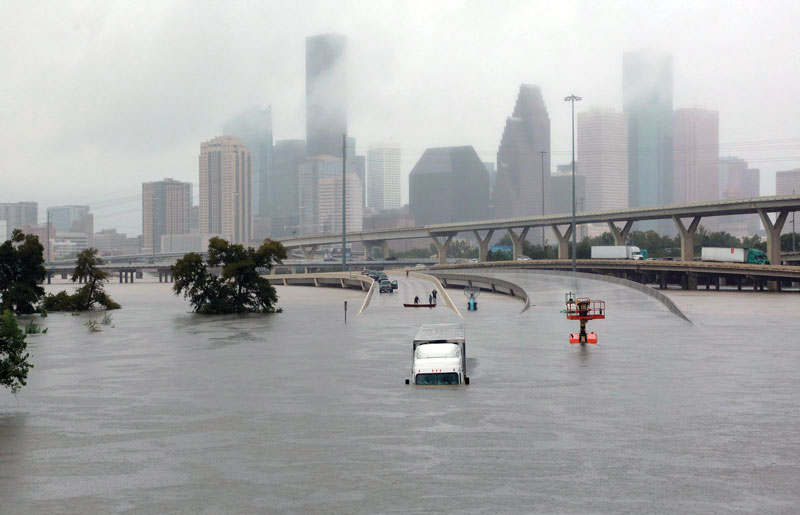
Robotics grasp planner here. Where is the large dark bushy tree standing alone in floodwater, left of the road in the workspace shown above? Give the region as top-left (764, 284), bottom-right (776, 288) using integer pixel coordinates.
top-left (172, 238), bottom-right (286, 314)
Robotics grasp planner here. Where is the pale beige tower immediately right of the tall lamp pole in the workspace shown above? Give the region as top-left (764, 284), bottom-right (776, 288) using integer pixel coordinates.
top-left (580, 109), bottom-right (628, 214)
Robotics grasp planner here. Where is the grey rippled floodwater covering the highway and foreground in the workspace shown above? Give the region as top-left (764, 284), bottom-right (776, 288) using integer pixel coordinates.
top-left (0, 273), bottom-right (800, 514)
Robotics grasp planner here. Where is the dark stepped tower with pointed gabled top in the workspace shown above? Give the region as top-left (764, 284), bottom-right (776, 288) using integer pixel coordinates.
top-left (491, 84), bottom-right (550, 218)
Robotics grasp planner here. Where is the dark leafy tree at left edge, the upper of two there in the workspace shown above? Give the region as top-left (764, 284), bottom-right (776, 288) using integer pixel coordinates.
top-left (0, 229), bottom-right (46, 313)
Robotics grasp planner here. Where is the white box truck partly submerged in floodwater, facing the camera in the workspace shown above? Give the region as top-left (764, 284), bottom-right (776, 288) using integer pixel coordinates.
top-left (406, 324), bottom-right (469, 386)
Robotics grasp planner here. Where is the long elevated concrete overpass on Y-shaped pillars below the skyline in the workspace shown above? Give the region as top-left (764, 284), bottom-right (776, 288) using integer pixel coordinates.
top-left (279, 195), bottom-right (800, 264)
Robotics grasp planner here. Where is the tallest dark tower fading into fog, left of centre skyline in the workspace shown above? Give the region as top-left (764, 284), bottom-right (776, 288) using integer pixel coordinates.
top-left (306, 34), bottom-right (347, 157)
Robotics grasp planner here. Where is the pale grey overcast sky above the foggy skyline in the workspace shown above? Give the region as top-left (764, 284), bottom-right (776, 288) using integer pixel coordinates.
top-left (0, 0), bottom-right (800, 236)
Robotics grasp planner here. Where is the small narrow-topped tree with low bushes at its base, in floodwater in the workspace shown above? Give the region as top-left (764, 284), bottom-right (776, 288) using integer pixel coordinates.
top-left (42, 248), bottom-right (120, 311)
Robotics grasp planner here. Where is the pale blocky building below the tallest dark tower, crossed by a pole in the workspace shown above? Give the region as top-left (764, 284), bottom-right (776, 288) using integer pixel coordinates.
top-left (298, 156), bottom-right (363, 234)
